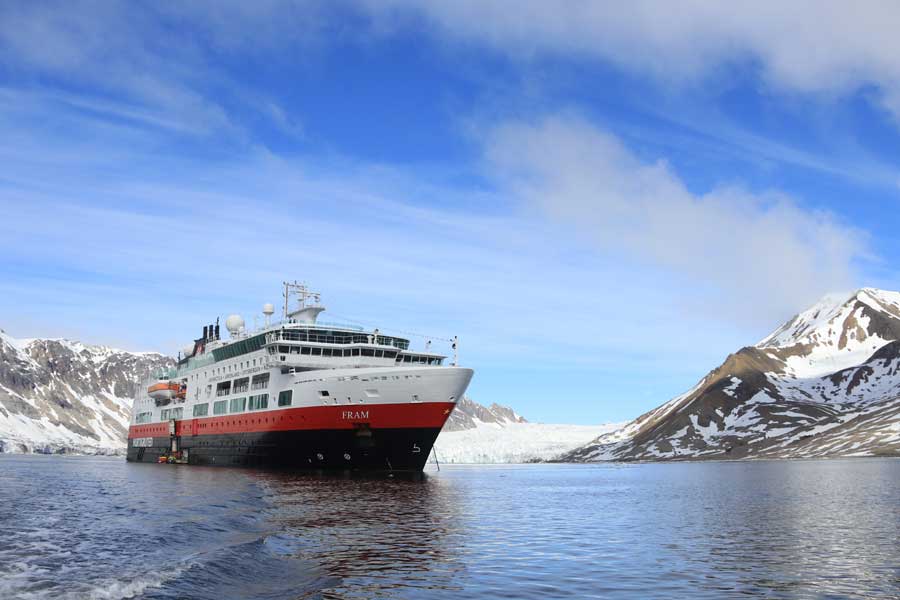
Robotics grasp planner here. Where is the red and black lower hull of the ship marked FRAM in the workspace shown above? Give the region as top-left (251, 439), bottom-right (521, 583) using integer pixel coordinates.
top-left (127, 402), bottom-right (455, 471)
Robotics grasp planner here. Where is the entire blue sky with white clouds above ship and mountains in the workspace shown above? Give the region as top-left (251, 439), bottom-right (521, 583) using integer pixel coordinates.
top-left (0, 0), bottom-right (900, 423)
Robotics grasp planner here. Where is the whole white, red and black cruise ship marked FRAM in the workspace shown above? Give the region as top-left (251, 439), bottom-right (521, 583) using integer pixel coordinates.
top-left (127, 282), bottom-right (473, 471)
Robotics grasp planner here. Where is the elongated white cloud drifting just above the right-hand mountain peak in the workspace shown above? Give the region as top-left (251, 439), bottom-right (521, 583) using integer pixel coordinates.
top-left (487, 116), bottom-right (866, 325)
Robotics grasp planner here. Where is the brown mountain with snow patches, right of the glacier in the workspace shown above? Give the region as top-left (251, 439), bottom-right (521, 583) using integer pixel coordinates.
top-left (562, 288), bottom-right (900, 461)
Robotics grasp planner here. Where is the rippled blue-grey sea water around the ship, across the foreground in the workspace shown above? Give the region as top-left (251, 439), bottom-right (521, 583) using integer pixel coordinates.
top-left (0, 456), bottom-right (900, 600)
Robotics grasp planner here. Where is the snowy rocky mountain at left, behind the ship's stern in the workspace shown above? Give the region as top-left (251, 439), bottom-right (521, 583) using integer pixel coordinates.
top-left (0, 331), bottom-right (174, 453)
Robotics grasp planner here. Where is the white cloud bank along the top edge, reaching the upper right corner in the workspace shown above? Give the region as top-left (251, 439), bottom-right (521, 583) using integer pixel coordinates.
top-left (363, 0), bottom-right (900, 122)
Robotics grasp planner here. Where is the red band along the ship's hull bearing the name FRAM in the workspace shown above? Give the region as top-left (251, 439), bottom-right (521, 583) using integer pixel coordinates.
top-left (128, 402), bottom-right (455, 439)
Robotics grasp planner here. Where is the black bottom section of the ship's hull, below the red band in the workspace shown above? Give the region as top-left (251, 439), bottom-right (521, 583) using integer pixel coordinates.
top-left (127, 428), bottom-right (441, 471)
